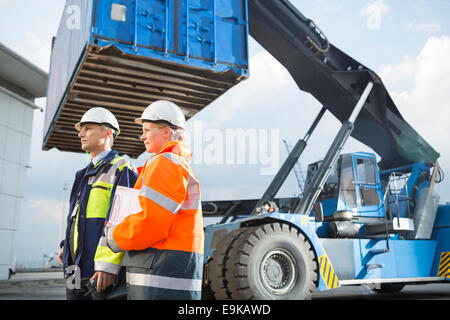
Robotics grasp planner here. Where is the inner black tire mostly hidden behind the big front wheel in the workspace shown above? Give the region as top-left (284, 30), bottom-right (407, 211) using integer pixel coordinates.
top-left (207, 228), bottom-right (248, 300)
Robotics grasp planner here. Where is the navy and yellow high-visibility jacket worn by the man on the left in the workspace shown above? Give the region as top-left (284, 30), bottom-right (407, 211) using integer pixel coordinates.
top-left (63, 151), bottom-right (137, 278)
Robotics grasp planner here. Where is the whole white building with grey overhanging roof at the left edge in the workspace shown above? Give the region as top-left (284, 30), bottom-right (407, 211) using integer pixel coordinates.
top-left (0, 43), bottom-right (47, 280)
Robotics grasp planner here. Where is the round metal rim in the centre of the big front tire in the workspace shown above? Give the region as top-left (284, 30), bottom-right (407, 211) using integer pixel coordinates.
top-left (260, 248), bottom-right (297, 295)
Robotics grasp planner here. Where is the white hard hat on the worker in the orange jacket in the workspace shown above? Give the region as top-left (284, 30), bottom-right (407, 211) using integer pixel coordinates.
top-left (134, 100), bottom-right (186, 129)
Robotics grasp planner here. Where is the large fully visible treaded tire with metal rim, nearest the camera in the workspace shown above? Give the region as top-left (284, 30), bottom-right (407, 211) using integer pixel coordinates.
top-left (226, 223), bottom-right (318, 300)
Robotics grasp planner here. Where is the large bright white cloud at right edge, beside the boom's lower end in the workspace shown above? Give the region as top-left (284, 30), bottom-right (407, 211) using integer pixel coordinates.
top-left (380, 36), bottom-right (450, 201)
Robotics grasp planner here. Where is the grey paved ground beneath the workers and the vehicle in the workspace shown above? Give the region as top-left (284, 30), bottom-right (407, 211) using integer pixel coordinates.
top-left (0, 272), bottom-right (450, 300)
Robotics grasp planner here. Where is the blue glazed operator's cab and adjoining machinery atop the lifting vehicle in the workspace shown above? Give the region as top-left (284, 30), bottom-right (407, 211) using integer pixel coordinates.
top-left (305, 152), bottom-right (437, 239)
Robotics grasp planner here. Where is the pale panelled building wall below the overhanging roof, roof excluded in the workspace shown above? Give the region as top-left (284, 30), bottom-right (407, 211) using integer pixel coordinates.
top-left (0, 87), bottom-right (34, 280)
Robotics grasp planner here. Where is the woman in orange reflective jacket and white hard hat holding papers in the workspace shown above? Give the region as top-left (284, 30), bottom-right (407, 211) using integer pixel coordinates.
top-left (106, 100), bottom-right (204, 300)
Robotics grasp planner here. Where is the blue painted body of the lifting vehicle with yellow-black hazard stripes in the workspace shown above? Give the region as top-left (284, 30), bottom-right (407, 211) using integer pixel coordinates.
top-left (204, 153), bottom-right (450, 290)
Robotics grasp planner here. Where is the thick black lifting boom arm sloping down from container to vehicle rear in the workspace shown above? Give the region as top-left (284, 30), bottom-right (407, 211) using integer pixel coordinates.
top-left (248, 0), bottom-right (439, 169)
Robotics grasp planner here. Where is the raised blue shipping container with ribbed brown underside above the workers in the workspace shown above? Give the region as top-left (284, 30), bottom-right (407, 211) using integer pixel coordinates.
top-left (43, 0), bottom-right (249, 157)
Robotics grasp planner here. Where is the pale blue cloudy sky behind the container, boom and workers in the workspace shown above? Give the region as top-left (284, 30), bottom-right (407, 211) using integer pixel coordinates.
top-left (0, 0), bottom-right (450, 264)
